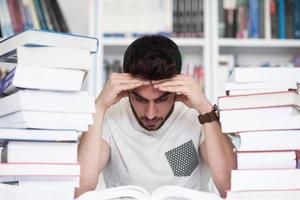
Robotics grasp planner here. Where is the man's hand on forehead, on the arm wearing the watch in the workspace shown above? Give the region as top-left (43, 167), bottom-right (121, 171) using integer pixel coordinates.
top-left (151, 74), bottom-right (212, 114)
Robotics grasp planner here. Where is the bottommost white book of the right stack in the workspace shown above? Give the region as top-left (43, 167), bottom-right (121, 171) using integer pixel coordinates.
top-left (226, 190), bottom-right (300, 200)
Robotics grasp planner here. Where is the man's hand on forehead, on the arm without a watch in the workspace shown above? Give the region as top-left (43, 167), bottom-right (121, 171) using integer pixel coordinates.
top-left (96, 73), bottom-right (150, 110)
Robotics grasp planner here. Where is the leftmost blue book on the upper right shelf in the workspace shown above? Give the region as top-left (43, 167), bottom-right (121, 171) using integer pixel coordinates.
top-left (249, 0), bottom-right (260, 38)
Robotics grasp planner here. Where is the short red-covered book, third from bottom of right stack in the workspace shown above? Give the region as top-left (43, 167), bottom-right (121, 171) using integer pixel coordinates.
top-left (237, 151), bottom-right (297, 169)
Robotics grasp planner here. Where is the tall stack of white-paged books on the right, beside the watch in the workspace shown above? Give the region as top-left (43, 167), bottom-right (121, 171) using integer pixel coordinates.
top-left (218, 67), bottom-right (300, 200)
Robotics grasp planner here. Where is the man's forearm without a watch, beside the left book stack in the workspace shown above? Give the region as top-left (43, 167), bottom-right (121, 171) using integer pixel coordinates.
top-left (75, 106), bottom-right (105, 196)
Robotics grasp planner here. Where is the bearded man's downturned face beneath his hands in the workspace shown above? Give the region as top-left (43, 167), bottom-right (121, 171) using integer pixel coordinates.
top-left (129, 85), bottom-right (175, 131)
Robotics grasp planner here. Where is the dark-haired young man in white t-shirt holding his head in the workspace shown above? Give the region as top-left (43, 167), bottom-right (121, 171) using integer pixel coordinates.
top-left (76, 36), bottom-right (236, 196)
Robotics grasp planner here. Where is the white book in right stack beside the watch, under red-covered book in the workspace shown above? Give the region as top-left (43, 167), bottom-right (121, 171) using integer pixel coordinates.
top-left (220, 106), bottom-right (300, 122)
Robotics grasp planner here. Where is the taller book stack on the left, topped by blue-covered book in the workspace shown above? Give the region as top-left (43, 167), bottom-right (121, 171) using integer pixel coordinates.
top-left (0, 30), bottom-right (98, 200)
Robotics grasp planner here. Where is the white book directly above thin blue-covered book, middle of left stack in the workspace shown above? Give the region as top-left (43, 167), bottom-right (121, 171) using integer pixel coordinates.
top-left (0, 110), bottom-right (93, 127)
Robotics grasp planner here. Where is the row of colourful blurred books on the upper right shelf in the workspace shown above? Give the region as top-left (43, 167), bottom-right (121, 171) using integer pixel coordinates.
top-left (218, 0), bottom-right (300, 39)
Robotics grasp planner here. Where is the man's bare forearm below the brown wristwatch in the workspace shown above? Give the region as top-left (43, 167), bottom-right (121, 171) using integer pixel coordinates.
top-left (203, 121), bottom-right (236, 197)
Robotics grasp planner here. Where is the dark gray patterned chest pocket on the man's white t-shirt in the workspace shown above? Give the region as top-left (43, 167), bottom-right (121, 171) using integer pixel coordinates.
top-left (165, 140), bottom-right (199, 176)
